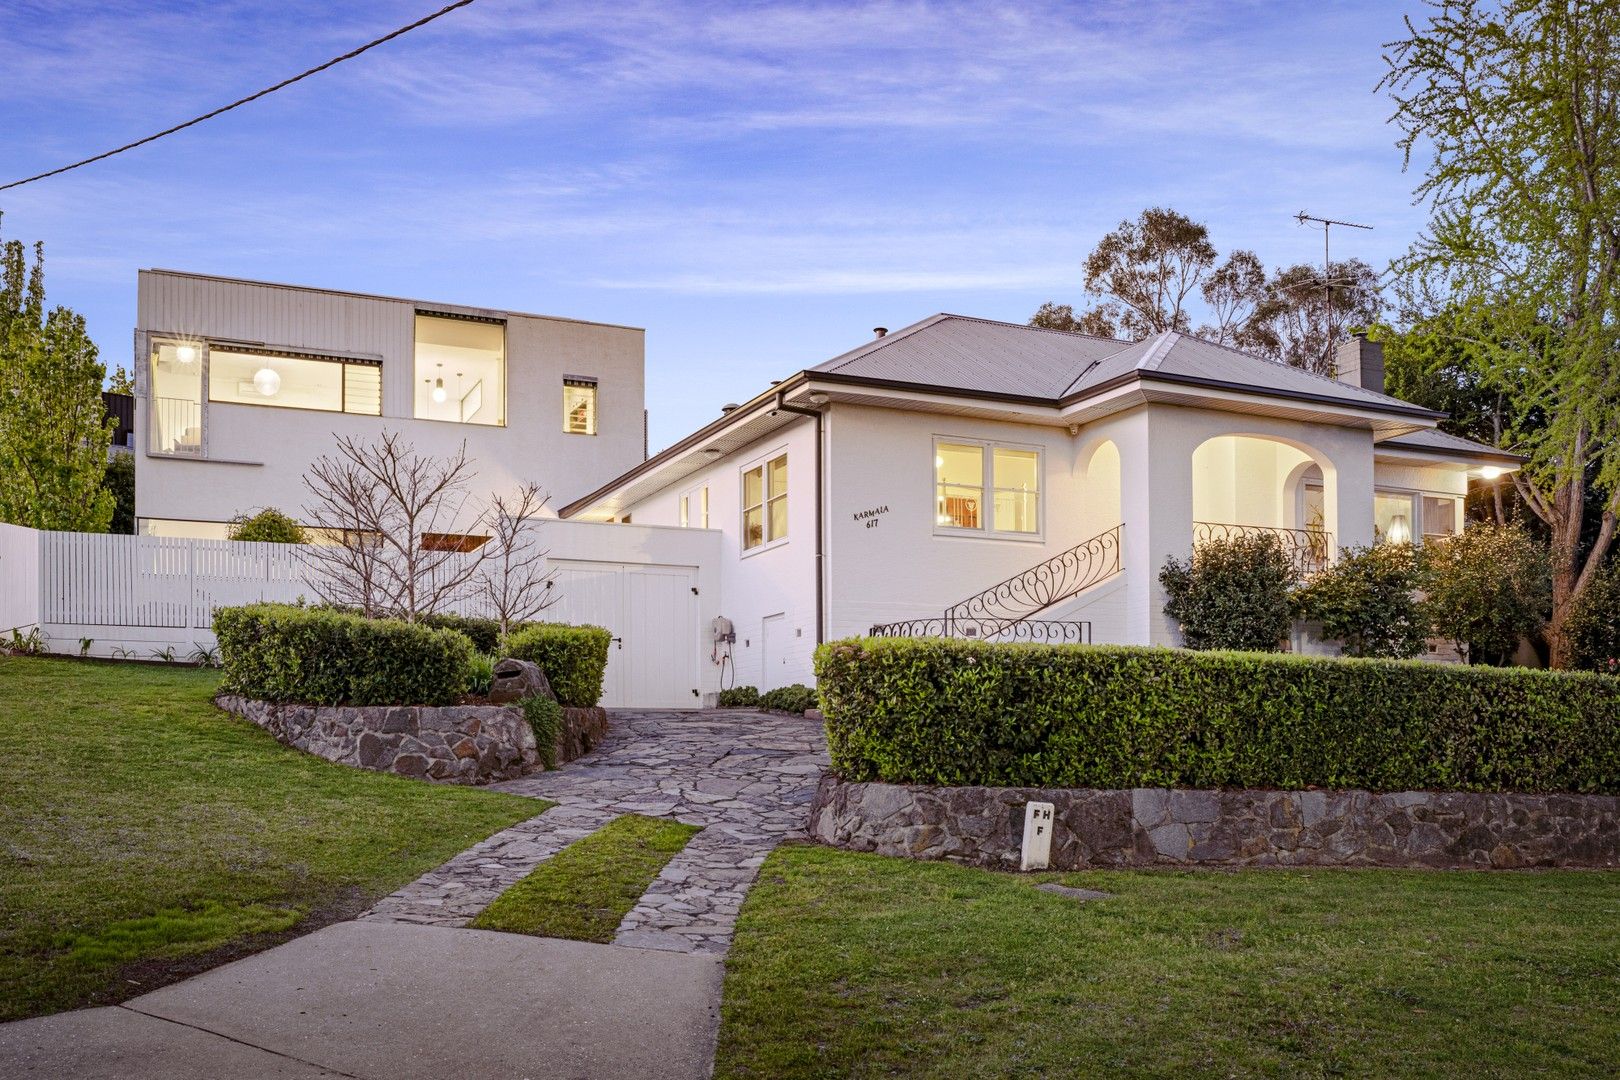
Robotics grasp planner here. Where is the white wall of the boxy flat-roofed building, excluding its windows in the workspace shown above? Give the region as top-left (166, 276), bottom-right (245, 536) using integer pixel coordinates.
top-left (134, 272), bottom-right (645, 537)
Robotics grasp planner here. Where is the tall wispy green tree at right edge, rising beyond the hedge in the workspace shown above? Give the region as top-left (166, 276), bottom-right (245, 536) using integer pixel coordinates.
top-left (1380, 0), bottom-right (1620, 667)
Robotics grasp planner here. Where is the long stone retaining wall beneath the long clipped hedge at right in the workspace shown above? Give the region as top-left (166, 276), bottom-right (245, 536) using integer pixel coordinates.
top-left (810, 776), bottom-right (1620, 870)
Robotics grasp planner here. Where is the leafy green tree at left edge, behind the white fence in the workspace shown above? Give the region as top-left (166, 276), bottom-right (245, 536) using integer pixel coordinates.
top-left (0, 213), bottom-right (115, 533)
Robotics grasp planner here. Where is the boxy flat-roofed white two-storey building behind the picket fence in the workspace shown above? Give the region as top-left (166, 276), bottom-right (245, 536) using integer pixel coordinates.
top-left (134, 270), bottom-right (646, 539)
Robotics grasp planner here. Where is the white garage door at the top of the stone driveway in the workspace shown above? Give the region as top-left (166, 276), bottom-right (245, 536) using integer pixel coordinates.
top-left (541, 559), bottom-right (700, 709)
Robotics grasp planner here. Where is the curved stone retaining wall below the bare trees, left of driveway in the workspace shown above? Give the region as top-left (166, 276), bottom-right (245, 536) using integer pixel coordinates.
top-left (215, 695), bottom-right (608, 784)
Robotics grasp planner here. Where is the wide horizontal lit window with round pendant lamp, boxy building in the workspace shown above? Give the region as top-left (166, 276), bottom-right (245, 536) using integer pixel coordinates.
top-left (207, 348), bottom-right (382, 416)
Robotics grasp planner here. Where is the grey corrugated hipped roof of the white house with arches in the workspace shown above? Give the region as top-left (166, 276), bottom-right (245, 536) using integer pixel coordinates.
top-left (810, 314), bottom-right (1427, 413)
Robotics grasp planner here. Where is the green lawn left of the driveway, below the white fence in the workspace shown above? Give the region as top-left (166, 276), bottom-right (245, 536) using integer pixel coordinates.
top-left (0, 657), bottom-right (548, 1020)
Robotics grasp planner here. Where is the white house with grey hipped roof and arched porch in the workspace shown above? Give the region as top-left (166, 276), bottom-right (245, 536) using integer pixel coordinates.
top-left (559, 314), bottom-right (1520, 688)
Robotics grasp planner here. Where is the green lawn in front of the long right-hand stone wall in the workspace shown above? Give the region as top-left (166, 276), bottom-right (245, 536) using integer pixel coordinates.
top-left (716, 845), bottom-right (1620, 1078)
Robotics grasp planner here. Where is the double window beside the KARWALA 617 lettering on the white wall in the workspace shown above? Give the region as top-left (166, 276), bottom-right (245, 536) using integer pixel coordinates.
top-left (933, 439), bottom-right (1040, 536)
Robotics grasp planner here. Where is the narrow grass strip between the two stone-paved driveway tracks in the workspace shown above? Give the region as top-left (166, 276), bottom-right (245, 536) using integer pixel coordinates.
top-left (471, 814), bottom-right (700, 942)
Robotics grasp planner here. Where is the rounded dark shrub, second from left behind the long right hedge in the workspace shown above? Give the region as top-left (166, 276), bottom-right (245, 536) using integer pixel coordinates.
top-left (1294, 544), bottom-right (1429, 659)
